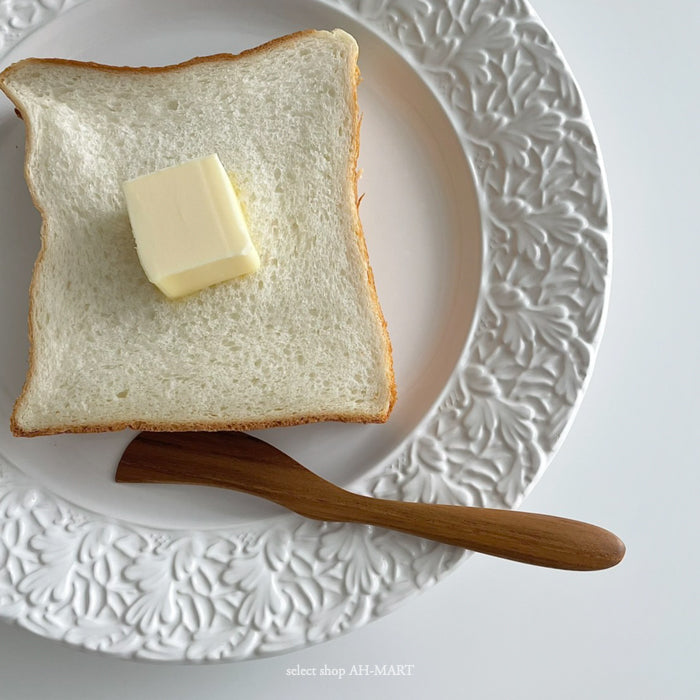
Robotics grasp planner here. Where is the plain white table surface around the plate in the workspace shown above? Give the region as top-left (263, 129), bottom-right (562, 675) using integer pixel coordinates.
top-left (0, 0), bottom-right (700, 700)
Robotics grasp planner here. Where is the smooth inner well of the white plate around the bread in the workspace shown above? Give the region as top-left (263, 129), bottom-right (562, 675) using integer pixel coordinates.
top-left (0, 0), bottom-right (482, 528)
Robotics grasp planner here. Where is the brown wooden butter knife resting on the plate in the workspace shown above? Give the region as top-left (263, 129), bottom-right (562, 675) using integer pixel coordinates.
top-left (115, 432), bottom-right (625, 571)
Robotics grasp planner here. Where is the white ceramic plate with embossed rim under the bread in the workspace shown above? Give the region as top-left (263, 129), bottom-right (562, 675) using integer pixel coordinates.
top-left (0, 0), bottom-right (610, 662)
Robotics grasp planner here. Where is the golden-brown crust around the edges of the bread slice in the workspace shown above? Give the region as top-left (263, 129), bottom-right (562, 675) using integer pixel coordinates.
top-left (0, 29), bottom-right (396, 437)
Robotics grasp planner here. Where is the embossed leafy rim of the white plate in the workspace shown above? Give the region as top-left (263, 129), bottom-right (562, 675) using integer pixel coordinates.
top-left (0, 0), bottom-right (610, 662)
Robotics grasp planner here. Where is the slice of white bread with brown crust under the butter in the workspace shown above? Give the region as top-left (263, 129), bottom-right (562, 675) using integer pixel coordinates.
top-left (0, 30), bottom-right (395, 436)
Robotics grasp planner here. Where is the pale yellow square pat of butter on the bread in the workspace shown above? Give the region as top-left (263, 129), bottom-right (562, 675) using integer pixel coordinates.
top-left (123, 155), bottom-right (260, 299)
